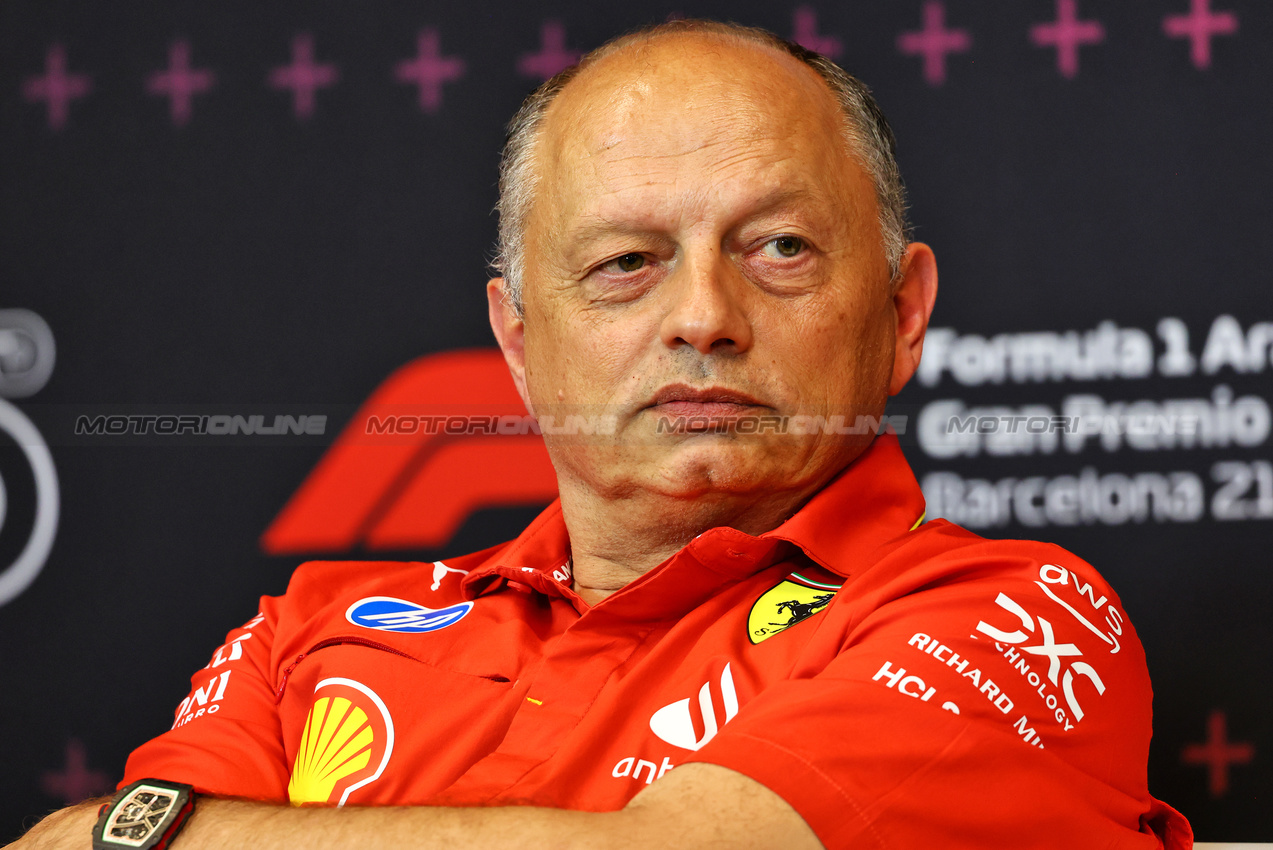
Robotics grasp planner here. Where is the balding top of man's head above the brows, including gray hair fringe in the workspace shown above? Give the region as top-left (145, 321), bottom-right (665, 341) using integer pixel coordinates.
top-left (494, 20), bottom-right (909, 310)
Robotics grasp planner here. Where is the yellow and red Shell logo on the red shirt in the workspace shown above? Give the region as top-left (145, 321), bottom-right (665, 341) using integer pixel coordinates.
top-left (288, 678), bottom-right (393, 805)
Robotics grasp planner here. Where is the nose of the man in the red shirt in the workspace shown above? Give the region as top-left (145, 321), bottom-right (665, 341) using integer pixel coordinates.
top-left (659, 251), bottom-right (751, 354)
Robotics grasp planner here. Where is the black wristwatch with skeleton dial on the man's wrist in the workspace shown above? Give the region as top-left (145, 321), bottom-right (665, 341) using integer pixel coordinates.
top-left (93, 779), bottom-right (195, 850)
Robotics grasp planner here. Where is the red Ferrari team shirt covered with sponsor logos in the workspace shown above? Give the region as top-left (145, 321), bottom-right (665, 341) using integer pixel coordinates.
top-left (123, 436), bottom-right (1190, 849)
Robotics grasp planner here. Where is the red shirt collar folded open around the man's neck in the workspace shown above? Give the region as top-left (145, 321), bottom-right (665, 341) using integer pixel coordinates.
top-left (462, 434), bottom-right (924, 601)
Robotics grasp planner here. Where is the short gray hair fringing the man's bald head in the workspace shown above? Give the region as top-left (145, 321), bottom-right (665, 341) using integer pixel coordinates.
top-left (491, 19), bottom-right (910, 316)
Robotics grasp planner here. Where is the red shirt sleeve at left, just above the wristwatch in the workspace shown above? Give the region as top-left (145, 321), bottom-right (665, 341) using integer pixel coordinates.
top-left (120, 597), bottom-right (289, 802)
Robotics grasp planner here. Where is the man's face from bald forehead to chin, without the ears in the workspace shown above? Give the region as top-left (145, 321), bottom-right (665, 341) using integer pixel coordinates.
top-left (502, 36), bottom-right (916, 508)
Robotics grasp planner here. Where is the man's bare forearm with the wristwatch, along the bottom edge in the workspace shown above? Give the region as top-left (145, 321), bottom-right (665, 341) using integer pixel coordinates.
top-left (9, 763), bottom-right (822, 850)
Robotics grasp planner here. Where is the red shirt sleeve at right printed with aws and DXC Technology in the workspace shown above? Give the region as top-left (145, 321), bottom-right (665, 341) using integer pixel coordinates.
top-left (687, 543), bottom-right (1192, 850)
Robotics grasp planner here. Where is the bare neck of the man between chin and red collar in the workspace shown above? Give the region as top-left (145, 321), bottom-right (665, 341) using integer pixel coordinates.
top-left (561, 482), bottom-right (817, 604)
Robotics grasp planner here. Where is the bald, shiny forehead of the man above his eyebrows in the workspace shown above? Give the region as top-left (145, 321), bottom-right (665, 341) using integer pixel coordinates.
top-left (532, 34), bottom-right (861, 230)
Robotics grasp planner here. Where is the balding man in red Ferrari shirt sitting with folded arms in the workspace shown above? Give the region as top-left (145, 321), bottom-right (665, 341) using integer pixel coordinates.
top-left (20, 22), bottom-right (1192, 849)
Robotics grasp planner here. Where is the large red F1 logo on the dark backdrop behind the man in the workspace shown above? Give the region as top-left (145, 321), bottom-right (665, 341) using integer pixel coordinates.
top-left (261, 349), bottom-right (558, 555)
